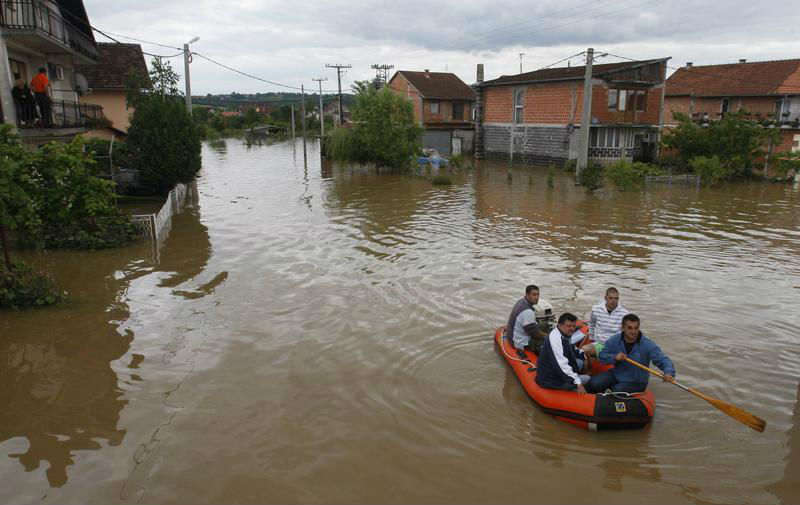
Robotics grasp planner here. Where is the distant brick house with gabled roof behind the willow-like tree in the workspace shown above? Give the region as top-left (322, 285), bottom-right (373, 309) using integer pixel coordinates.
top-left (389, 70), bottom-right (475, 155)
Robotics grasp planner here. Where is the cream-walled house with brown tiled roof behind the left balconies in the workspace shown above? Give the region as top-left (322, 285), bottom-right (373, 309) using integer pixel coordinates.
top-left (75, 42), bottom-right (150, 138)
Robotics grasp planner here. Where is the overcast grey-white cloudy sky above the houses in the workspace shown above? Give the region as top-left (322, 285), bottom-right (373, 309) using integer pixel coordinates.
top-left (85, 0), bottom-right (800, 95)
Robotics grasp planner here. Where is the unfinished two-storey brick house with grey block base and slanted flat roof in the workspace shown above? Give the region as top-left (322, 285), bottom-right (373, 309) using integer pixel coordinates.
top-left (475, 58), bottom-right (669, 164)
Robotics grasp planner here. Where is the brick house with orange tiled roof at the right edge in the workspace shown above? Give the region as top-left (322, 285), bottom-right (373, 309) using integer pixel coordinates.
top-left (664, 59), bottom-right (800, 161)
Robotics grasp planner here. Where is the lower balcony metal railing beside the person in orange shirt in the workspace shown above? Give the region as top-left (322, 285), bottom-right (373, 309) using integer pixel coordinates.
top-left (16, 96), bottom-right (106, 129)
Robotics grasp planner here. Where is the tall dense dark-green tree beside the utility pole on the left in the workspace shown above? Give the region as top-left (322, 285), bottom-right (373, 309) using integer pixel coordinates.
top-left (127, 58), bottom-right (200, 194)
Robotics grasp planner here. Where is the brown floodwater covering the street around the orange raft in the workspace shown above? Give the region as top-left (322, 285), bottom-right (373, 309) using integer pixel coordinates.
top-left (0, 139), bottom-right (800, 504)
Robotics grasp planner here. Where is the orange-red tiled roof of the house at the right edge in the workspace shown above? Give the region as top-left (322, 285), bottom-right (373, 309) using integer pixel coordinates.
top-left (666, 59), bottom-right (800, 96)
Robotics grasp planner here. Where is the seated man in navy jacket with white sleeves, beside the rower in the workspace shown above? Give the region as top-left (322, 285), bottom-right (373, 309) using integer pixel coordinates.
top-left (536, 312), bottom-right (590, 394)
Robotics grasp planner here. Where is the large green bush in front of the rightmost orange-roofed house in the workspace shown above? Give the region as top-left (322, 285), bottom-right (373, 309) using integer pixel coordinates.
top-left (662, 111), bottom-right (779, 184)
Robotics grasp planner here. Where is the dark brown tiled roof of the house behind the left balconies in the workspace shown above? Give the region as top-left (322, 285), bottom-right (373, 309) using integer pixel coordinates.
top-left (75, 42), bottom-right (149, 89)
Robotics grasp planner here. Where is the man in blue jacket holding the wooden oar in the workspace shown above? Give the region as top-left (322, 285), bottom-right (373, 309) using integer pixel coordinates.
top-left (586, 314), bottom-right (675, 393)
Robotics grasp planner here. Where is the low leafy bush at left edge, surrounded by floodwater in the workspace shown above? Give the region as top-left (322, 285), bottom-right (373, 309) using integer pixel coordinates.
top-left (0, 262), bottom-right (65, 308)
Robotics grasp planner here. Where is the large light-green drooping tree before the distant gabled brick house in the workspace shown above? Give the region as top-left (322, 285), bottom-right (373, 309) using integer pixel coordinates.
top-left (325, 86), bottom-right (422, 167)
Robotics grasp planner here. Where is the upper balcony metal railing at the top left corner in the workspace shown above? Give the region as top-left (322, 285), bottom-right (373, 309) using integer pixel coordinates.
top-left (0, 0), bottom-right (97, 60)
